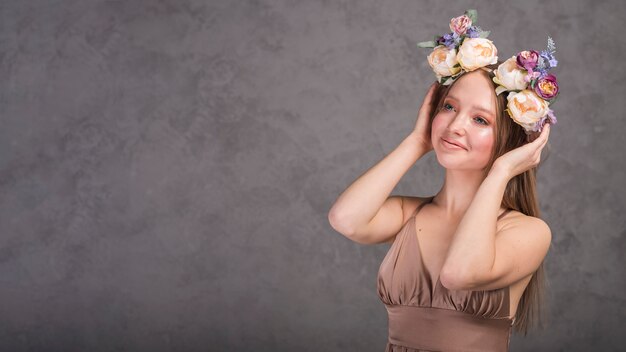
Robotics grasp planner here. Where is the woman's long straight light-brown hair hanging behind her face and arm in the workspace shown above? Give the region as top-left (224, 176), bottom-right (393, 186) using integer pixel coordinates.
top-left (429, 61), bottom-right (550, 336)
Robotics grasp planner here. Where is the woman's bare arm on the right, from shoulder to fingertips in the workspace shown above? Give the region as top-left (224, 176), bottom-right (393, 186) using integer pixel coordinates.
top-left (440, 125), bottom-right (552, 290)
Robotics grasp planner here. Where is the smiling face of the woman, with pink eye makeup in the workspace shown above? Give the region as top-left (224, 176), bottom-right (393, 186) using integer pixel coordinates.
top-left (431, 70), bottom-right (496, 170)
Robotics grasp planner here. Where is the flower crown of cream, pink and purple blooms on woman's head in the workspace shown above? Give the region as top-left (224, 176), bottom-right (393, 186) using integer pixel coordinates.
top-left (417, 9), bottom-right (559, 134)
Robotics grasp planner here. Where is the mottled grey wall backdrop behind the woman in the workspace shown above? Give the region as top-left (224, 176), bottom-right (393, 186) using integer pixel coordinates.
top-left (0, 0), bottom-right (626, 352)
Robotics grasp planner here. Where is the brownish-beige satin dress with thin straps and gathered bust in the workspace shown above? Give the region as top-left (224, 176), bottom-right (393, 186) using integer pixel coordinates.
top-left (377, 197), bottom-right (514, 352)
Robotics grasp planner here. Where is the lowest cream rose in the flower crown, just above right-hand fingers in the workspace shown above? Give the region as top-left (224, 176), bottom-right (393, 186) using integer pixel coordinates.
top-left (507, 89), bottom-right (548, 131)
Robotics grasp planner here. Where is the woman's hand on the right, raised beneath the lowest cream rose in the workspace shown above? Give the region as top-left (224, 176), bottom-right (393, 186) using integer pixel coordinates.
top-left (493, 123), bottom-right (550, 178)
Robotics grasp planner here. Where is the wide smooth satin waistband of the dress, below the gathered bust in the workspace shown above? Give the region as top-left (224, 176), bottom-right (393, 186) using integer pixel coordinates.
top-left (385, 304), bottom-right (513, 352)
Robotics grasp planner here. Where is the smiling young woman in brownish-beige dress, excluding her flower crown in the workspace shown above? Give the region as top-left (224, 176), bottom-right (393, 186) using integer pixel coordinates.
top-left (329, 62), bottom-right (551, 351)
